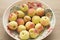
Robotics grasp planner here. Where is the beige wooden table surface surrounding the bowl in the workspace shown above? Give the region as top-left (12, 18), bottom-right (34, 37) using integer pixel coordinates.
top-left (0, 0), bottom-right (60, 40)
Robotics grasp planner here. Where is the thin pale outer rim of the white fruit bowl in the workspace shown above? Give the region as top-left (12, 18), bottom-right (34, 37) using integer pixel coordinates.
top-left (2, 0), bottom-right (56, 40)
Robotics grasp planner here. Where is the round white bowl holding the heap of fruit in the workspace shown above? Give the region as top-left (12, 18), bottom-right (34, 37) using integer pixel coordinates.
top-left (3, 0), bottom-right (56, 40)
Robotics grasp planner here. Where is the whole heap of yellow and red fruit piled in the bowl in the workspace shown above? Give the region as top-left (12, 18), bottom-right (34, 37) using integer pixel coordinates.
top-left (7, 2), bottom-right (52, 39)
